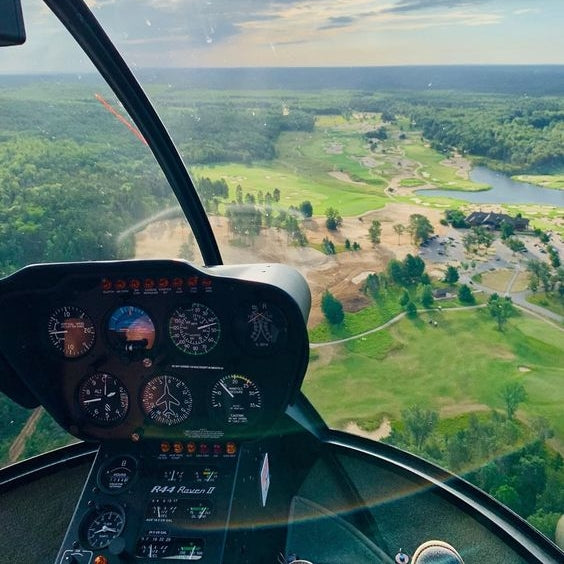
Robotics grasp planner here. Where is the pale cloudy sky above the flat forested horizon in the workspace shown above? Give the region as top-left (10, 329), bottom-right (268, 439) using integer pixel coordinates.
top-left (0, 0), bottom-right (564, 72)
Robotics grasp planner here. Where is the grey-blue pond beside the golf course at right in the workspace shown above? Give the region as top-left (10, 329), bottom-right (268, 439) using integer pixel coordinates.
top-left (415, 166), bottom-right (564, 207)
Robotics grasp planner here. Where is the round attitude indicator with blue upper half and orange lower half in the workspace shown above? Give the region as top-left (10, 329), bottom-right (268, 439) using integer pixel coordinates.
top-left (108, 305), bottom-right (155, 352)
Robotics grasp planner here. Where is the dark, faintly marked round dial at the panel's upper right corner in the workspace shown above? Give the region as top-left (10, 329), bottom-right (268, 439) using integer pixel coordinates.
top-left (235, 302), bottom-right (288, 354)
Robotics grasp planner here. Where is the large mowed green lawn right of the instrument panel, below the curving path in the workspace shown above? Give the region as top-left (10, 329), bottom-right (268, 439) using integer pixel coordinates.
top-left (303, 309), bottom-right (564, 447)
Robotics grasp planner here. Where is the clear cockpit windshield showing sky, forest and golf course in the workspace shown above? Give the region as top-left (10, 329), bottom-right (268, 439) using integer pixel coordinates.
top-left (0, 0), bottom-right (564, 539)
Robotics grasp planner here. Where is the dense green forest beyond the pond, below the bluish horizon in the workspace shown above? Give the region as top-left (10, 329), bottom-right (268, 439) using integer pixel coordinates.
top-left (351, 92), bottom-right (564, 174)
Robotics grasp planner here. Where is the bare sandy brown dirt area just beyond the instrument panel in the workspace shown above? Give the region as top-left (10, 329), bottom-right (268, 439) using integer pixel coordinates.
top-left (136, 203), bottom-right (445, 326)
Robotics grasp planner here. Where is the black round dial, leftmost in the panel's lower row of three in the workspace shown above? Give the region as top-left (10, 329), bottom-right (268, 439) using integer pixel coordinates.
top-left (78, 372), bottom-right (129, 425)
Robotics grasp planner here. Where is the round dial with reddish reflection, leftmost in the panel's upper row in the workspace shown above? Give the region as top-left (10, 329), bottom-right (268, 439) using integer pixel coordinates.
top-left (47, 306), bottom-right (96, 358)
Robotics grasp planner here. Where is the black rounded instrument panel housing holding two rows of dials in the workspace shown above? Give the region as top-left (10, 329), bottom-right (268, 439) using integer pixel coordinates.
top-left (0, 260), bottom-right (310, 442)
